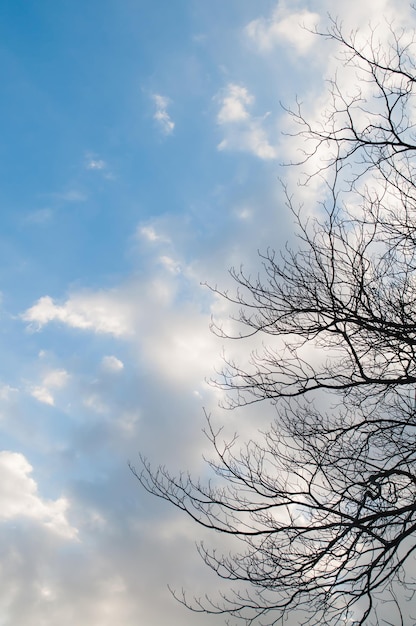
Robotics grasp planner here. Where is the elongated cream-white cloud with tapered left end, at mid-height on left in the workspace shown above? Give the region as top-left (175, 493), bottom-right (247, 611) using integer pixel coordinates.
top-left (21, 291), bottom-right (132, 337)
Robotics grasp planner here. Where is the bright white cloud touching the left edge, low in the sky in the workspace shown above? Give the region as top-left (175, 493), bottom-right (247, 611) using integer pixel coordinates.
top-left (0, 450), bottom-right (77, 539)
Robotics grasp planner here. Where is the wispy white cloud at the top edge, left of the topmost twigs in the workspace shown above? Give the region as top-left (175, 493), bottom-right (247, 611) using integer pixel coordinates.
top-left (246, 2), bottom-right (319, 55)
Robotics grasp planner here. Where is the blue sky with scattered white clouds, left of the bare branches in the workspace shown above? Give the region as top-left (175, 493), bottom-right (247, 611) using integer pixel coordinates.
top-left (0, 0), bottom-right (415, 626)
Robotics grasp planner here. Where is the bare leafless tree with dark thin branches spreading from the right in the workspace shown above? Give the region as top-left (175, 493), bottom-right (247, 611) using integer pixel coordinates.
top-left (133, 15), bottom-right (416, 626)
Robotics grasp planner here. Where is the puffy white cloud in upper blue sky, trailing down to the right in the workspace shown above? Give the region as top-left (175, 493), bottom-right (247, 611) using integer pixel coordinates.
top-left (217, 83), bottom-right (277, 160)
